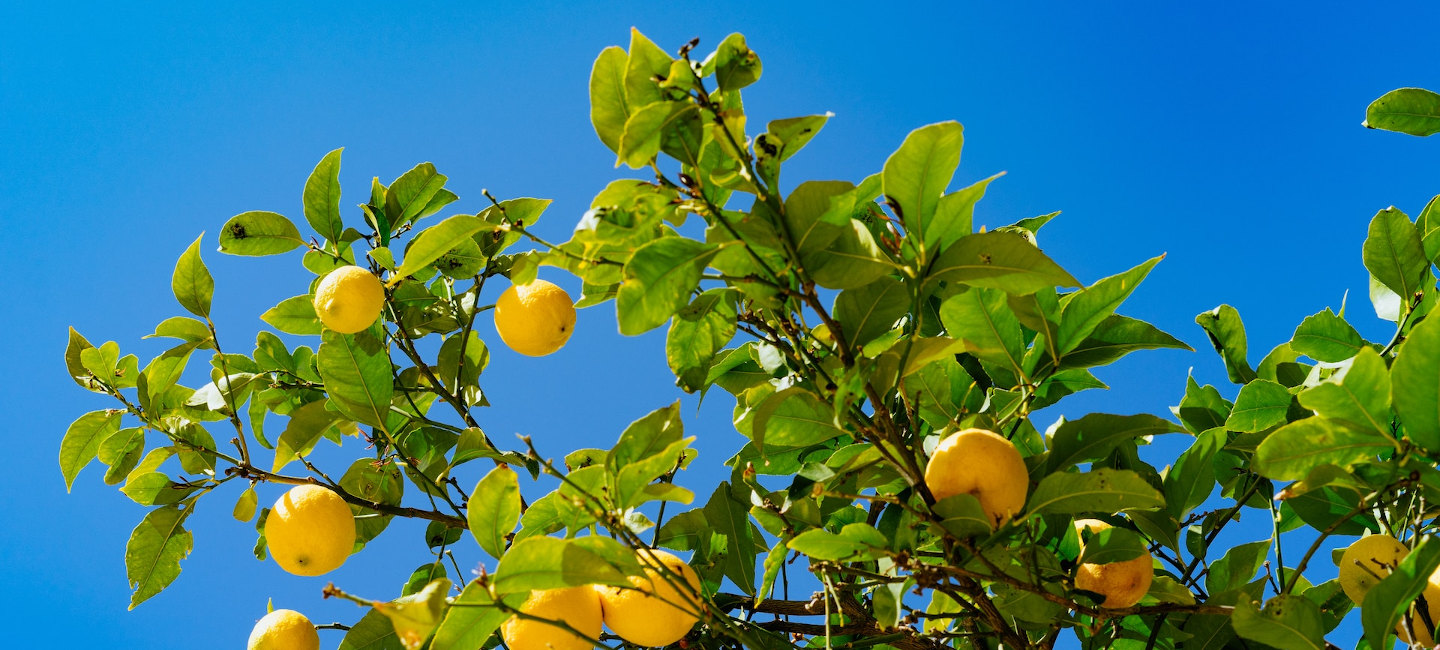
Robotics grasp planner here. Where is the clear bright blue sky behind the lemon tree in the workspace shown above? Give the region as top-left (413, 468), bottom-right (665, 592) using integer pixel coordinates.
top-left (0, 1), bottom-right (1440, 649)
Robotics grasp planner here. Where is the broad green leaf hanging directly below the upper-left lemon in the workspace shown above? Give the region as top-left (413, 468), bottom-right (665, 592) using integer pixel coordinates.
top-left (317, 330), bottom-right (395, 431)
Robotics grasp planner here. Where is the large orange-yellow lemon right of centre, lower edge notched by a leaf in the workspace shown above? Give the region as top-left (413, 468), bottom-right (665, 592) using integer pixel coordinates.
top-left (924, 429), bottom-right (1030, 526)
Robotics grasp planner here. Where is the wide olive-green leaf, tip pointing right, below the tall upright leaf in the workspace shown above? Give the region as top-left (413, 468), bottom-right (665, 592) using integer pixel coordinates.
top-left (924, 231), bottom-right (1080, 295)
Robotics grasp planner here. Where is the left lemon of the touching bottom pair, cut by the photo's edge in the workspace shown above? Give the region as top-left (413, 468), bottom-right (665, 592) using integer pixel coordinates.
top-left (500, 587), bottom-right (600, 650)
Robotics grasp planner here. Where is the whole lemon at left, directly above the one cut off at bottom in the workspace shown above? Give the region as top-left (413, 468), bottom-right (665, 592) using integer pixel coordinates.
top-left (265, 486), bottom-right (356, 575)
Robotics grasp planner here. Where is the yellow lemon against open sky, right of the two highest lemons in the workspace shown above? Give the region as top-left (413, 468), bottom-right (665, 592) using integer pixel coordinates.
top-left (495, 280), bottom-right (575, 356)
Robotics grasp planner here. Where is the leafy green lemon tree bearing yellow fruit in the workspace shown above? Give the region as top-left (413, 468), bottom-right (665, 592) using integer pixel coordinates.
top-left (59, 32), bottom-right (1440, 650)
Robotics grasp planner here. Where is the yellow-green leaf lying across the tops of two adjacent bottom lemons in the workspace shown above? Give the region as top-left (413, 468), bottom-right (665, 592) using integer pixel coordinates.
top-left (492, 538), bottom-right (628, 594)
